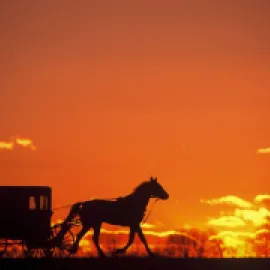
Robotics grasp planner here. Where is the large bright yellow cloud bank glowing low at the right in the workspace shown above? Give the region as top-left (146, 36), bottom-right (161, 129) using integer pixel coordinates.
top-left (202, 194), bottom-right (270, 257)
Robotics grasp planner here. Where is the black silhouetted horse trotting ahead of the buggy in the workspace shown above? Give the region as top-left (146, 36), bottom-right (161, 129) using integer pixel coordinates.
top-left (54, 177), bottom-right (169, 257)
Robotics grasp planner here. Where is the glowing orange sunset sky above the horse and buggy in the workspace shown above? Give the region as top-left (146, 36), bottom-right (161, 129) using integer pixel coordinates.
top-left (0, 0), bottom-right (270, 249)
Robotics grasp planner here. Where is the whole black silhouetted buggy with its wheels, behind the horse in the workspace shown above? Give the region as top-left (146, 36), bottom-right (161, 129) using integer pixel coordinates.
top-left (0, 186), bottom-right (74, 258)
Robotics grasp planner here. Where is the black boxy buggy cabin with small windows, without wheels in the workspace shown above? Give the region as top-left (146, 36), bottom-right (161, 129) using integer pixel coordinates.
top-left (0, 186), bottom-right (52, 246)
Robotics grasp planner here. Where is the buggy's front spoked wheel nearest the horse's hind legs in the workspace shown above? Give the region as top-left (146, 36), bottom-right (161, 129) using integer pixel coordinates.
top-left (48, 224), bottom-right (75, 258)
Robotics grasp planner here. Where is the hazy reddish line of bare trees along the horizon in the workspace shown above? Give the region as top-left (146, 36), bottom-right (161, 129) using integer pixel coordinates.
top-left (4, 223), bottom-right (270, 258)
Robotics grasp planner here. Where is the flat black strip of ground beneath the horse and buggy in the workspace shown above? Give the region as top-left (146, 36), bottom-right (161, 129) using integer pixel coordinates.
top-left (0, 258), bottom-right (270, 270)
